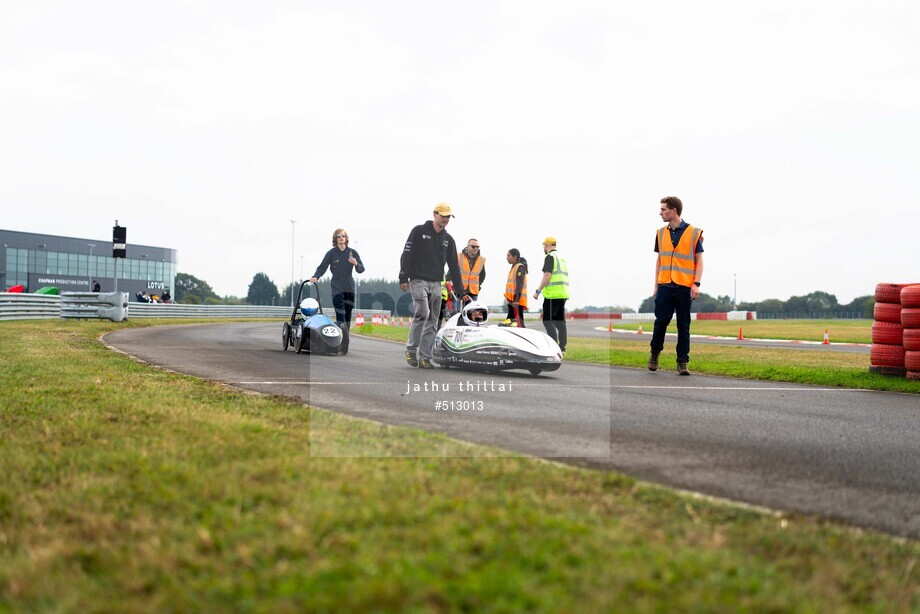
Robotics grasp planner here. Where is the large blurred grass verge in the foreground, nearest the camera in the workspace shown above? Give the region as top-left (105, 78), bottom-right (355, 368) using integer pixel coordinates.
top-left (0, 322), bottom-right (920, 612)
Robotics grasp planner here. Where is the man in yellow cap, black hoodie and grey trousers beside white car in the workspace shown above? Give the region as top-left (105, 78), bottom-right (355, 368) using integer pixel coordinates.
top-left (399, 203), bottom-right (469, 369)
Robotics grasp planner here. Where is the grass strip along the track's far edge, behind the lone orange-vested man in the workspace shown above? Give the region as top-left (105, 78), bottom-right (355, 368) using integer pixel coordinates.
top-left (352, 324), bottom-right (920, 393)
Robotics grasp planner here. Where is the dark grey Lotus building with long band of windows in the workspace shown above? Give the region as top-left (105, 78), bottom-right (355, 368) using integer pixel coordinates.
top-left (0, 229), bottom-right (177, 298)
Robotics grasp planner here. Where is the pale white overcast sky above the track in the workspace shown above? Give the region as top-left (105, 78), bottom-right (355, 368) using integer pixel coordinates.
top-left (0, 0), bottom-right (920, 308)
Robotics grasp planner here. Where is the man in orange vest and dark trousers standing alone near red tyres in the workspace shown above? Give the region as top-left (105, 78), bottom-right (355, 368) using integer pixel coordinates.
top-left (648, 196), bottom-right (703, 375)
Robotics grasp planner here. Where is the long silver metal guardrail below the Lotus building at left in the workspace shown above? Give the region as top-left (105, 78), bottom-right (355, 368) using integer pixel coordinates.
top-left (0, 292), bottom-right (391, 320)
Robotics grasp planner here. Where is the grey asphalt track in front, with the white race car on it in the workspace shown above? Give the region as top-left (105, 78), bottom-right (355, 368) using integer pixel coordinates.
top-left (105, 322), bottom-right (920, 538)
